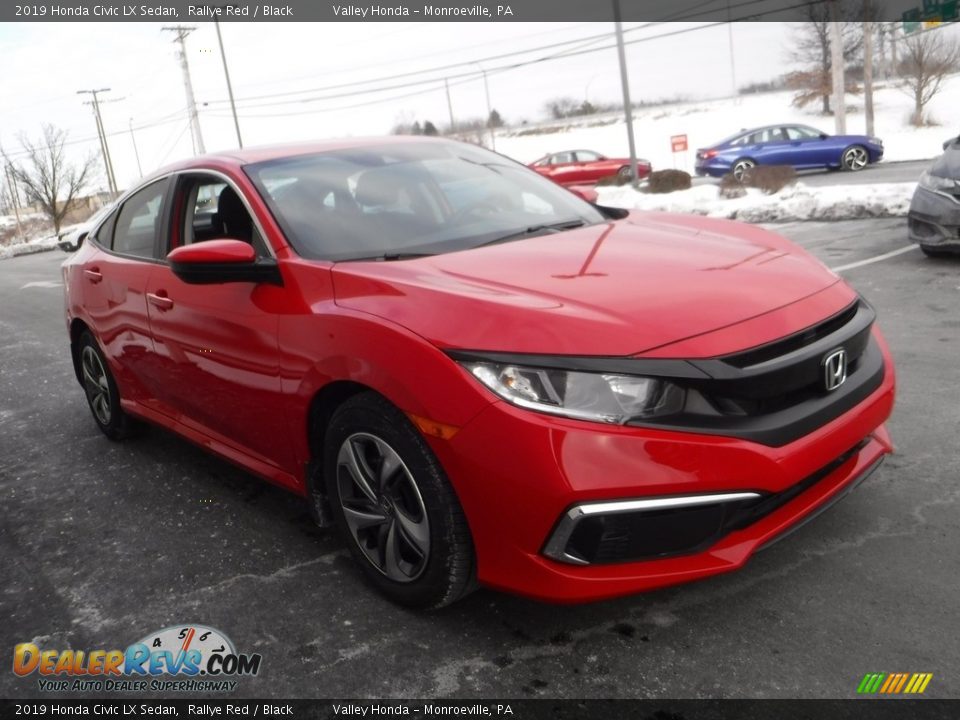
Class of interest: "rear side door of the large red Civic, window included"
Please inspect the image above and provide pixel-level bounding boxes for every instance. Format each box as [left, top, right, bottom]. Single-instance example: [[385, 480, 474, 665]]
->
[[79, 178, 170, 406]]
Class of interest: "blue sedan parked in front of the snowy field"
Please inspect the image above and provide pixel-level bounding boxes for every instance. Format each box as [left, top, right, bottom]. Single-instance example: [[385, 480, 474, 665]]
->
[[696, 125, 883, 178]]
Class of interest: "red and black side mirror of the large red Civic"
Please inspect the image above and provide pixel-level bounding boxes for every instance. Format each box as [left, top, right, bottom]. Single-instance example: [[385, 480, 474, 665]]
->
[[167, 239, 283, 285]]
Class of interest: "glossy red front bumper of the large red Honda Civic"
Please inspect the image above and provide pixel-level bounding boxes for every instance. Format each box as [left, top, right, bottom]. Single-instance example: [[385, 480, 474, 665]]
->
[[430, 333, 894, 602]]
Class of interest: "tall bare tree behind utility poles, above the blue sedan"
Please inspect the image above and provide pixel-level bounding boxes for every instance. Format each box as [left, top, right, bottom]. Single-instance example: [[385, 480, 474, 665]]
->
[[786, 0, 863, 115]]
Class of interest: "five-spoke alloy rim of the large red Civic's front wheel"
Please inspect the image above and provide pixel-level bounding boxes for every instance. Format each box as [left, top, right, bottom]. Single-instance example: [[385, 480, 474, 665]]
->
[[337, 433, 430, 583]]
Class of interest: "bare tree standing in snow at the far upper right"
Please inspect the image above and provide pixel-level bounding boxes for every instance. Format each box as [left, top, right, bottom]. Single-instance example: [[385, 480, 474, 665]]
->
[[900, 31, 960, 127]]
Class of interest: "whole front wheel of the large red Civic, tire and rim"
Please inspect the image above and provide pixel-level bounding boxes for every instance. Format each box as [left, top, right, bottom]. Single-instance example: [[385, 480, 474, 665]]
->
[[324, 392, 476, 609]]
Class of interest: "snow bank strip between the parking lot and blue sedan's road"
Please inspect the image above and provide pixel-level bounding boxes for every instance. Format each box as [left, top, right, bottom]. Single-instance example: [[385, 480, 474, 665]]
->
[[597, 183, 917, 223]]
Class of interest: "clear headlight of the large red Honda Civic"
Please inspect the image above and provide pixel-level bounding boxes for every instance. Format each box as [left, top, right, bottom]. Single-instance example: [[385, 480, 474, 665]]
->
[[461, 361, 686, 425]]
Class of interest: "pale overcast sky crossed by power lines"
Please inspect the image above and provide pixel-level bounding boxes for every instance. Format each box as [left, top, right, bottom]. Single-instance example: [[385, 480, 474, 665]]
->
[[0, 22, 796, 189]]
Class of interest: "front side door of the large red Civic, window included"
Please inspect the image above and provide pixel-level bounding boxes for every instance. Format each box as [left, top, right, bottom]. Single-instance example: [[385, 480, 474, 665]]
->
[[146, 172, 293, 477]]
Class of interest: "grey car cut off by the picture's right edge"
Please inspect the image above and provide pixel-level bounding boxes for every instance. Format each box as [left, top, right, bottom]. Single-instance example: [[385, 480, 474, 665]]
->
[[907, 137, 960, 257]]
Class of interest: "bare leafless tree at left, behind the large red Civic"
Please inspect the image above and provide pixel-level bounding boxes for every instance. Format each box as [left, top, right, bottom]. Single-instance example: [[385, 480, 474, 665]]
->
[[4, 125, 96, 234]]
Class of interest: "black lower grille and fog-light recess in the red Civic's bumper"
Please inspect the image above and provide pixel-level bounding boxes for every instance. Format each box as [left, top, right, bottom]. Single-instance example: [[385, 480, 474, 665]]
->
[[544, 439, 868, 565]]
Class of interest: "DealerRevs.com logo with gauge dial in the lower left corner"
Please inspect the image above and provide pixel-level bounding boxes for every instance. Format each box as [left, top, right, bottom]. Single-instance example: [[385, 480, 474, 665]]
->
[[13, 625, 262, 692]]
